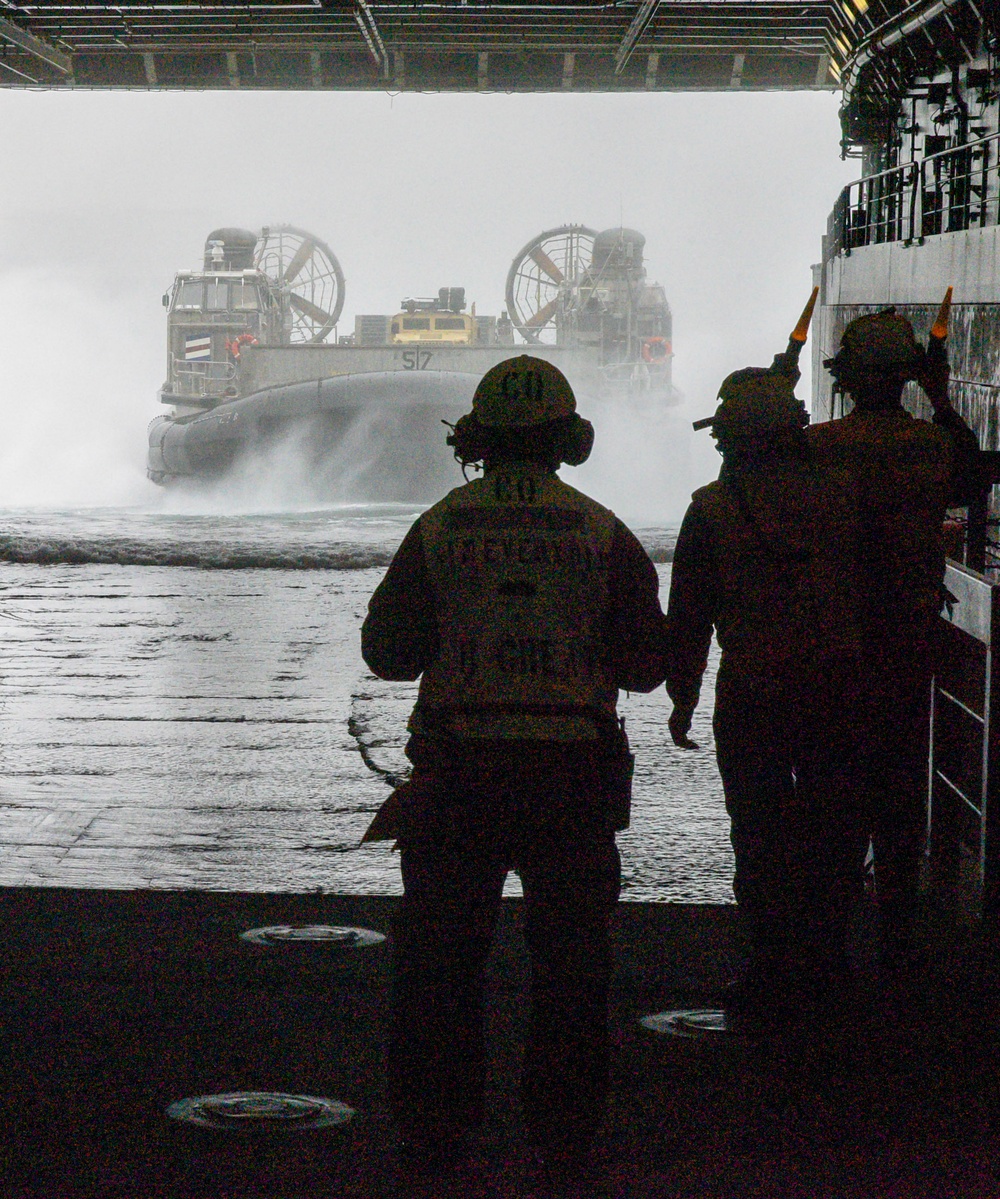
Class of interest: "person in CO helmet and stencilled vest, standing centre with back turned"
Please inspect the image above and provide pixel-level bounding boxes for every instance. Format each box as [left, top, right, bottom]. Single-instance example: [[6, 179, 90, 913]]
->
[[362, 355, 663, 1189]]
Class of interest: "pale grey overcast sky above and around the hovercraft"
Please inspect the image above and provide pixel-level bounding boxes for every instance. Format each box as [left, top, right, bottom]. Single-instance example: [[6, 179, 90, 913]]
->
[[0, 90, 856, 504]]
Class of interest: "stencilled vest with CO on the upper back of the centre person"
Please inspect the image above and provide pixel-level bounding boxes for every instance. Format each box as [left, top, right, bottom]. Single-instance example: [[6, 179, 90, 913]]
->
[[410, 463, 618, 741]]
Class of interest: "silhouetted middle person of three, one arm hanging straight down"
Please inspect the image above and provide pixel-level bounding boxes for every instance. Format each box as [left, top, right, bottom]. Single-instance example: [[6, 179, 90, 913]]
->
[[667, 369, 867, 1014]]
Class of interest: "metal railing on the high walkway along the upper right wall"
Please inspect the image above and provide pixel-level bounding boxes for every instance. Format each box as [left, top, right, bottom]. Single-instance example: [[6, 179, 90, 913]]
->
[[826, 133, 1000, 257]]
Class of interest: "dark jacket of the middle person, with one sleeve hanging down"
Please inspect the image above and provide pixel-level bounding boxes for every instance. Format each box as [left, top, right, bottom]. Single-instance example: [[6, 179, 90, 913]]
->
[[667, 462, 860, 703]]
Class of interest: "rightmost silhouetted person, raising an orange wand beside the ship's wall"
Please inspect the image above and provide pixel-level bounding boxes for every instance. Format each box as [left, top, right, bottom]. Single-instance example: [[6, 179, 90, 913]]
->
[[808, 297, 978, 965]]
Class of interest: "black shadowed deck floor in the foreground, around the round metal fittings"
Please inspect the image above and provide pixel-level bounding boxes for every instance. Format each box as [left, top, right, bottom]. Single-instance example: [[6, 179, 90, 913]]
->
[[0, 888, 1000, 1199]]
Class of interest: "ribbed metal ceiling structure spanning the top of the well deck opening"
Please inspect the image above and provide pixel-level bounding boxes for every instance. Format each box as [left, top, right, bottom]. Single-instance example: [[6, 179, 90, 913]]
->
[[0, 0, 882, 91]]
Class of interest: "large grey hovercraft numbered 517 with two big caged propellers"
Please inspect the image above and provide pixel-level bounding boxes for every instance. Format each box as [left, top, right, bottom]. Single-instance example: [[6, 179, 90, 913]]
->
[[147, 225, 680, 502]]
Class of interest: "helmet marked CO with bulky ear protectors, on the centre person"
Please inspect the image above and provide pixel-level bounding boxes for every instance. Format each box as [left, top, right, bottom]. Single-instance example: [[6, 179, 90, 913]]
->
[[447, 354, 594, 466]]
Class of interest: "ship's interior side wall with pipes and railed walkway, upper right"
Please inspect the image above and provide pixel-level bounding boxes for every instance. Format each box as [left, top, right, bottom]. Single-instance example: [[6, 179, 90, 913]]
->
[[813, 0, 1000, 462]]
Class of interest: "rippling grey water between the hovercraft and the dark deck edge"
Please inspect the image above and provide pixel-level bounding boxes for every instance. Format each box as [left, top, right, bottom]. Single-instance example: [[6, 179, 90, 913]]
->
[[0, 505, 733, 903]]
